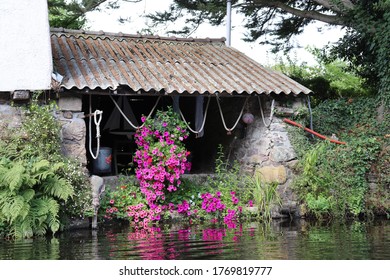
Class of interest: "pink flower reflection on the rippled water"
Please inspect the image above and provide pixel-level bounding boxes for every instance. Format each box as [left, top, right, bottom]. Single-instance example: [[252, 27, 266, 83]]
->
[[106, 225, 253, 260]]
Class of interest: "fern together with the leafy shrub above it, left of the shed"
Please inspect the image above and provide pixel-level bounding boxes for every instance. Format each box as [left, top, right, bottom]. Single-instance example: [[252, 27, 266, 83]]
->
[[0, 93, 92, 238]]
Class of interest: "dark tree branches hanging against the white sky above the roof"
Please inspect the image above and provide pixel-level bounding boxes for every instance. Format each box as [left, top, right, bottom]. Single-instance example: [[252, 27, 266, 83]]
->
[[148, 0, 355, 48]]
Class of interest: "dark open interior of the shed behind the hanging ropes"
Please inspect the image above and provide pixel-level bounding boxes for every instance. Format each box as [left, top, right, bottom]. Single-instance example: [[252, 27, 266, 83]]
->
[[83, 94, 243, 176]]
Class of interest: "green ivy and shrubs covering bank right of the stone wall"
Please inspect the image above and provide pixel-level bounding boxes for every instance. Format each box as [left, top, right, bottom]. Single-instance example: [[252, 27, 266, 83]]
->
[[292, 97, 390, 217]]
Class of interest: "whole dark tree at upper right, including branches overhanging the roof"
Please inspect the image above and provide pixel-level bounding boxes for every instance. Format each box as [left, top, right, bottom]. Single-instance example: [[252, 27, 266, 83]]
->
[[148, 0, 390, 104]]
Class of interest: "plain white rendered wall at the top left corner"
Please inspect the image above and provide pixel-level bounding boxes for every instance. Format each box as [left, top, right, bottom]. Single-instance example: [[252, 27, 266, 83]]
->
[[0, 0, 53, 91]]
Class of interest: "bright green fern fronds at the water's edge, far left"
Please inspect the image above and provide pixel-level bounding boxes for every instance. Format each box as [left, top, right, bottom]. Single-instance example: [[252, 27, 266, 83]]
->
[[0, 157, 73, 238]]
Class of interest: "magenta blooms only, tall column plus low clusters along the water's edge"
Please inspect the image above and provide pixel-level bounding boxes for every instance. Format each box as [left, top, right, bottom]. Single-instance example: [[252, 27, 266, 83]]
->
[[106, 109, 251, 229]]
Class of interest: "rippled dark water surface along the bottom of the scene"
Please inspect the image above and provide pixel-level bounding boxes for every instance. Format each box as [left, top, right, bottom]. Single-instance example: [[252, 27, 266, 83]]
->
[[0, 220, 390, 260]]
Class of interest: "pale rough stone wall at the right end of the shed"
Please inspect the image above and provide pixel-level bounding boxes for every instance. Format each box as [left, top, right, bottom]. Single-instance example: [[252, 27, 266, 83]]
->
[[234, 99, 304, 216]]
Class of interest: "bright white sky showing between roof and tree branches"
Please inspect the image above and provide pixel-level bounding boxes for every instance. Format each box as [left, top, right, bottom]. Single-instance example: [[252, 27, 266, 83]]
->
[[87, 0, 343, 65]]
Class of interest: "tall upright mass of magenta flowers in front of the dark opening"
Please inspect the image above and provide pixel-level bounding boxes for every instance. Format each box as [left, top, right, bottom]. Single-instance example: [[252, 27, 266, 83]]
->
[[134, 108, 191, 210]]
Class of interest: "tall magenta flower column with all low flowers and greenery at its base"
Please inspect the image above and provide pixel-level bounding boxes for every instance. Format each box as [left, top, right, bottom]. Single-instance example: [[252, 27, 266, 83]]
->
[[100, 108, 258, 229]]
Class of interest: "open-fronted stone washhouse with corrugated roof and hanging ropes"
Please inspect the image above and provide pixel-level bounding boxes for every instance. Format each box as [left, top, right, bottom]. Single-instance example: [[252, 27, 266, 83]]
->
[[0, 28, 312, 221]]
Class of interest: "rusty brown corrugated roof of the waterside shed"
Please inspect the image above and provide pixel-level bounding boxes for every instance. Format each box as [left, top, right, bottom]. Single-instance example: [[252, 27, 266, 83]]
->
[[51, 29, 311, 94]]
